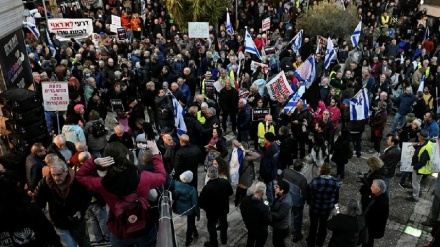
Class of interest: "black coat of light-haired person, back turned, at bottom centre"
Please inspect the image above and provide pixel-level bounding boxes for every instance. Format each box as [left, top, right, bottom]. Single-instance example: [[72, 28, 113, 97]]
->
[[240, 195, 272, 235]]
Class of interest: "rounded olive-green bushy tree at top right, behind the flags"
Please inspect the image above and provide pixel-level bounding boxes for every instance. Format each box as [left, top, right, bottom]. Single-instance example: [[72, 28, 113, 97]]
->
[[296, 1, 359, 38]]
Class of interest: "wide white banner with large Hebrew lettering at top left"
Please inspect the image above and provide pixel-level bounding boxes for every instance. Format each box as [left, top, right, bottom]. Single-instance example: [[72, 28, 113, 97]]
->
[[47, 18, 93, 41]]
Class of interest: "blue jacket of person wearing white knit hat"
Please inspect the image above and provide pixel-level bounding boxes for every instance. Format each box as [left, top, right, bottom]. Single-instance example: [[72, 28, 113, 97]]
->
[[173, 181, 200, 216]]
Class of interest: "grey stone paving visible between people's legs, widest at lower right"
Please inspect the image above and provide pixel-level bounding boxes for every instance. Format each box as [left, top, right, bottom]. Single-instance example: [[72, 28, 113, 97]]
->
[[99, 114, 435, 247]]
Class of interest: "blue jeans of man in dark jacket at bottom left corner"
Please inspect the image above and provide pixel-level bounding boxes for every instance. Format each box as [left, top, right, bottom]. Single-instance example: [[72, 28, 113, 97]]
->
[[55, 219, 91, 247]]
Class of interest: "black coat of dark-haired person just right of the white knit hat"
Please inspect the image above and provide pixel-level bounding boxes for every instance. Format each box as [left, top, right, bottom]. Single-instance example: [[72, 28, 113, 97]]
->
[[199, 178, 234, 217]]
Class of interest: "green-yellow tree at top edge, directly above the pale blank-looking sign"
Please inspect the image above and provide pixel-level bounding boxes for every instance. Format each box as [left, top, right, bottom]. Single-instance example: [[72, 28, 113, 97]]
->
[[166, 0, 231, 31]]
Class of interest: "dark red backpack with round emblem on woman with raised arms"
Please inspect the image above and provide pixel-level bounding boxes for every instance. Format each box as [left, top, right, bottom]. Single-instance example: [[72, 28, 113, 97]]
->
[[111, 174, 149, 239]]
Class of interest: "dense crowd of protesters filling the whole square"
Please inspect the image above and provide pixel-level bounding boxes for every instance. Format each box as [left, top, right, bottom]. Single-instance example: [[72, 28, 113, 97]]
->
[[0, 0, 440, 247]]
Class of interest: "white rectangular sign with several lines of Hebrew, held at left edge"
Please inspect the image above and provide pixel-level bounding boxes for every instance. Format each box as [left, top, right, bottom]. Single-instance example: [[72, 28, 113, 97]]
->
[[41, 82, 69, 111]]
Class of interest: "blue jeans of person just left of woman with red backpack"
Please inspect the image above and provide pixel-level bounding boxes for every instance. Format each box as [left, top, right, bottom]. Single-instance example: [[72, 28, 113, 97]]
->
[[86, 203, 110, 242]]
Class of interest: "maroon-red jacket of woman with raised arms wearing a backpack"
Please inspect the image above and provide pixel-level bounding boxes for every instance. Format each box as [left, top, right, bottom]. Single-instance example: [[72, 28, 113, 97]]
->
[[76, 154, 166, 235]]
